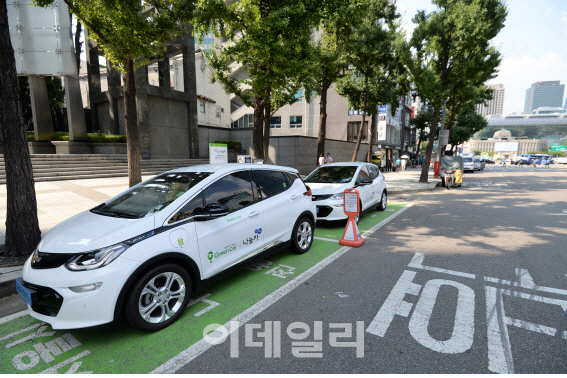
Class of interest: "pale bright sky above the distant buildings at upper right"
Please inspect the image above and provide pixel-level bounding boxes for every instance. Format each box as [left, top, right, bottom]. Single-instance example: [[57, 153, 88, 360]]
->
[[396, 0, 567, 114]]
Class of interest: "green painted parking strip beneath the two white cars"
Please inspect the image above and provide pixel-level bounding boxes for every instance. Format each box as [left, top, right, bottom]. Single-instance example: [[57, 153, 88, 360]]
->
[[0, 204, 406, 374]]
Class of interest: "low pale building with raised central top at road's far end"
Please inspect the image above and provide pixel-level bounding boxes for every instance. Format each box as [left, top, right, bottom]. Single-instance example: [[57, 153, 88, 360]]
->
[[463, 129, 547, 158]]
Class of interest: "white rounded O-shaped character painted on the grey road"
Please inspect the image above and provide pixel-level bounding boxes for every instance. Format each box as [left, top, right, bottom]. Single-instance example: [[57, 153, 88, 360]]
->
[[409, 279, 475, 354]]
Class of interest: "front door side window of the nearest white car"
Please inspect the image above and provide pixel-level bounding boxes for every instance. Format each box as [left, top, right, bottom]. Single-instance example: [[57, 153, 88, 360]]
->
[[205, 171, 254, 212]]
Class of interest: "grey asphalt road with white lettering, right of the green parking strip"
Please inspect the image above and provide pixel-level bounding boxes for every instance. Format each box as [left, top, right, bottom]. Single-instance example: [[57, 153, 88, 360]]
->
[[174, 166, 567, 374]]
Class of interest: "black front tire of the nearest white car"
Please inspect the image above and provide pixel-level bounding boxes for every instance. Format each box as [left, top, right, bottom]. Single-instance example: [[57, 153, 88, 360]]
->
[[124, 264, 192, 332]]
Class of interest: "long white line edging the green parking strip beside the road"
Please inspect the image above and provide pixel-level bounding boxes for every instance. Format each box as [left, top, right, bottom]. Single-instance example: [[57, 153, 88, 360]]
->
[[151, 203, 413, 374]]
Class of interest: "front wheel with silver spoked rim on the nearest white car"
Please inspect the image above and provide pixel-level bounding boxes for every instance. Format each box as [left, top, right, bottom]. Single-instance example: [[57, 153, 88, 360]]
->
[[125, 264, 191, 332]]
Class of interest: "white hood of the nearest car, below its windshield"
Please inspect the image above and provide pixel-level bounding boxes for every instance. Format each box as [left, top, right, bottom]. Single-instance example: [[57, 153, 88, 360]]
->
[[39, 211, 154, 253]]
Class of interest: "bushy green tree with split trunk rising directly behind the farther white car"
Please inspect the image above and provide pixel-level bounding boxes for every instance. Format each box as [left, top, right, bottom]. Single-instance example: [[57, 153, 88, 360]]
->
[[337, 0, 408, 161]]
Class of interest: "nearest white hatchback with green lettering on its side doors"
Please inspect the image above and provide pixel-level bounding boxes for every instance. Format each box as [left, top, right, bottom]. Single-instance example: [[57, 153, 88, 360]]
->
[[16, 164, 316, 331]]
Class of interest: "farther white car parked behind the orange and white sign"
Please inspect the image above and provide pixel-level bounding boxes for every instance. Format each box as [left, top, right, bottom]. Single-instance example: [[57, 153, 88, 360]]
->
[[305, 163, 388, 221]]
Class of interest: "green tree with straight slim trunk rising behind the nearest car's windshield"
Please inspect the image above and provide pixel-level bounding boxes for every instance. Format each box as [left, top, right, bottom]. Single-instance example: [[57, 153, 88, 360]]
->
[[36, 0, 194, 186]]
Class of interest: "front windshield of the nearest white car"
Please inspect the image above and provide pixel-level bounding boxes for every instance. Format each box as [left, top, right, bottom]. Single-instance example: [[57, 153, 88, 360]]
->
[[91, 172, 211, 218]]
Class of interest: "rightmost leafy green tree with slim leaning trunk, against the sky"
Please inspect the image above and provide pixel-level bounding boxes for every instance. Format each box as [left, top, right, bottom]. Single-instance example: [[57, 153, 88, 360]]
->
[[404, 0, 507, 182]]
